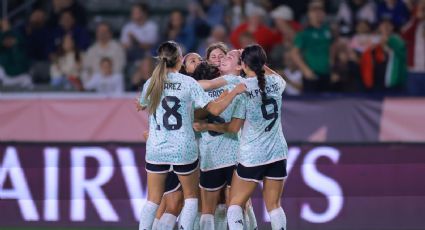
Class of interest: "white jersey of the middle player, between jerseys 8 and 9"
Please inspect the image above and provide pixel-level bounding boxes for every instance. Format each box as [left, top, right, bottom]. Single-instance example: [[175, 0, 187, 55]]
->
[[199, 82, 244, 171]]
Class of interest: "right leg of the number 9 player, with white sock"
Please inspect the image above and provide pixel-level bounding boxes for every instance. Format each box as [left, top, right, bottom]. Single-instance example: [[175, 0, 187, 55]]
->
[[263, 160, 286, 230]]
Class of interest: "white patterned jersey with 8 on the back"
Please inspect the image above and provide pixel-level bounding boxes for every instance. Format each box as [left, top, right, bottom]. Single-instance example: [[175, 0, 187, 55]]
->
[[140, 73, 212, 165]]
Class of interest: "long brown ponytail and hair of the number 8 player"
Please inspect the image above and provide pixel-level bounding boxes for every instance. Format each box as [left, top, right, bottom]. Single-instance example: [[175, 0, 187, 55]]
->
[[145, 41, 181, 114]]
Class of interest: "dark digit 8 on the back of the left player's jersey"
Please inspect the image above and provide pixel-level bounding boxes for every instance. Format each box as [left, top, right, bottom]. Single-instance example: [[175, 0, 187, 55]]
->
[[162, 96, 182, 130]]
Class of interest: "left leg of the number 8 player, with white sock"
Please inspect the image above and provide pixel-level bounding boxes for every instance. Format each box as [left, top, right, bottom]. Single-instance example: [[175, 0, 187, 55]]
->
[[139, 163, 169, 230]]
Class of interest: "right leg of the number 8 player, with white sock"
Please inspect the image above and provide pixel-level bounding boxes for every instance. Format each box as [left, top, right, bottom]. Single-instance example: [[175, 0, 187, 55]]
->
[[174, 161, 199, 230]]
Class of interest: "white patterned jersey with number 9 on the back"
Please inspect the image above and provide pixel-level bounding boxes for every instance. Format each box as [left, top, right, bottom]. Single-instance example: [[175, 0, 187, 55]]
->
[[232, 75, 288, 167]]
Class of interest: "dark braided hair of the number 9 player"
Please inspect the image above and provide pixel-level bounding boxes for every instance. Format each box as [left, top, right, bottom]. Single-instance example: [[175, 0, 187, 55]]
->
[[241, 44, 267, 100]]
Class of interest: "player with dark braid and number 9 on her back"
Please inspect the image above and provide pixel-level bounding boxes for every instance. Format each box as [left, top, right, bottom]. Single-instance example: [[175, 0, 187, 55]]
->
[[202, 45, 288, 230]]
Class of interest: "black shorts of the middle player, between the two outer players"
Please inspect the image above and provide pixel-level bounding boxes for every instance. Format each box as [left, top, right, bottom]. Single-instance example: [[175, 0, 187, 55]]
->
[[199, 165, 235, 192]]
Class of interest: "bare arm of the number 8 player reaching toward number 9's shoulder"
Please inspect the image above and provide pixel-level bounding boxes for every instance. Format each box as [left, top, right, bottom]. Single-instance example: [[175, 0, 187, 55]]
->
[[205, 83, 246, 116]]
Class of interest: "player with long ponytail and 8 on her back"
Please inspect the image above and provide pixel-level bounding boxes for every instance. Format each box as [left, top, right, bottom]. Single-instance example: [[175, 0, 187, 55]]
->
[[139, 41, 245, 229]]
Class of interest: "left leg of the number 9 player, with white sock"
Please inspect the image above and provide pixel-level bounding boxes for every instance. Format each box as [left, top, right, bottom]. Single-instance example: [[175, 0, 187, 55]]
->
[[227, 164, 262, 230]]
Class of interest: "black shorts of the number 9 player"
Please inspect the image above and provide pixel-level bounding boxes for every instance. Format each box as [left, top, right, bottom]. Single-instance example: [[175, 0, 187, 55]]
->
[[236, 159, 287, 183]]
